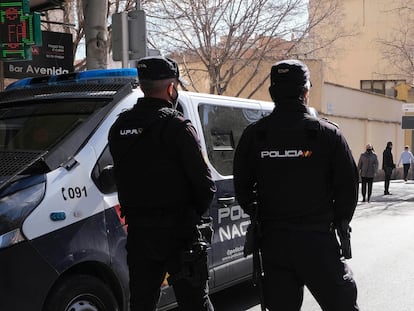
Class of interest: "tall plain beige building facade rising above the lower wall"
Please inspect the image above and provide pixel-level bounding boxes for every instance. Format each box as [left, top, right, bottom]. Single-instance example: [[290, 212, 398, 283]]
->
[[310, 0, 403, 89]]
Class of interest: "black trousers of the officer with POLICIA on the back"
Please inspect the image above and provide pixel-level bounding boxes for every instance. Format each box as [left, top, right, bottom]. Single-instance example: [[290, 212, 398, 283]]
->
[[261, 228, 359, 311]]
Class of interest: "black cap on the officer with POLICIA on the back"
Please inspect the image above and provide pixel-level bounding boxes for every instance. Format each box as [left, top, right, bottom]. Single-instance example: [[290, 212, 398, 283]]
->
[[270, 59, 310, 87]]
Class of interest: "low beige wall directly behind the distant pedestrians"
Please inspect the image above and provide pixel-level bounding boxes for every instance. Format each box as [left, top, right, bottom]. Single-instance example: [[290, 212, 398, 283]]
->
[[320, 82, 404, 165]]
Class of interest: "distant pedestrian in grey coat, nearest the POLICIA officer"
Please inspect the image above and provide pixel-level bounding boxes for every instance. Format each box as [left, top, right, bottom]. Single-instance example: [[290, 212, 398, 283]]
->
[[358, 144, 378, 202]]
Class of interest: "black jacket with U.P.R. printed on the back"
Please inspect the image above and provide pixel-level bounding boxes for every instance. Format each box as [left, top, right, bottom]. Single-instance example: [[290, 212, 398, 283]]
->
[[108, 98, 215, 226]]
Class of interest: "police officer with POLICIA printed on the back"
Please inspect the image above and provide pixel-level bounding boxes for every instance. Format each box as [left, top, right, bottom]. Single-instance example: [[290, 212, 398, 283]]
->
[[234, 60, 359, 311]]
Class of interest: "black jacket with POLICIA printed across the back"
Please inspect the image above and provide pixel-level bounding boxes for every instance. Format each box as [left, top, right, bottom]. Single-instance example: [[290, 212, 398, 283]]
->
[[234, 102, 358, 227]]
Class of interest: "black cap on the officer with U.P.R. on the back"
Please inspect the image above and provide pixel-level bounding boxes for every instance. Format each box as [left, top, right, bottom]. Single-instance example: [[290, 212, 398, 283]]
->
[[137, 56, 180, 80]]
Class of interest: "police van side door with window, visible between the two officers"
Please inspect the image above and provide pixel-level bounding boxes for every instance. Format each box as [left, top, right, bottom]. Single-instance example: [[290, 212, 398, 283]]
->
[[193, 97, 262, 287]]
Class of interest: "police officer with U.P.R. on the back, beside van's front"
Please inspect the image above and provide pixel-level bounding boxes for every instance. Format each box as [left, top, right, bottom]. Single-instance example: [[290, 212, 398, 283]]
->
[[109, 56, 215, 311]]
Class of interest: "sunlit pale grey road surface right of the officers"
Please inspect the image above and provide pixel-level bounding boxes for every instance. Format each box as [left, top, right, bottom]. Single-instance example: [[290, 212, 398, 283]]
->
[[244, 179, 414, 311]]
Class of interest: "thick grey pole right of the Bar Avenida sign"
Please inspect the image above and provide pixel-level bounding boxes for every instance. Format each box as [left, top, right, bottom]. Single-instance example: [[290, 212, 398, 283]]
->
[[83, 0, 108, 69]]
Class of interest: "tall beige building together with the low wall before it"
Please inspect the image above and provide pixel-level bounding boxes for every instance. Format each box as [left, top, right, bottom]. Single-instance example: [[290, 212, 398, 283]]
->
[[302, 0, 414, 173]]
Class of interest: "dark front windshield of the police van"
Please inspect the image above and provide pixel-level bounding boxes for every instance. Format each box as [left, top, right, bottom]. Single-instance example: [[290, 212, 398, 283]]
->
[[0, 100, 107, 151]]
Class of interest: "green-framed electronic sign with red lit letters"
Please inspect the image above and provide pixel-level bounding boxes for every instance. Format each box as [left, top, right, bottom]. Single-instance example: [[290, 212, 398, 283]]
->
[[0, 0, 42, 61]]
